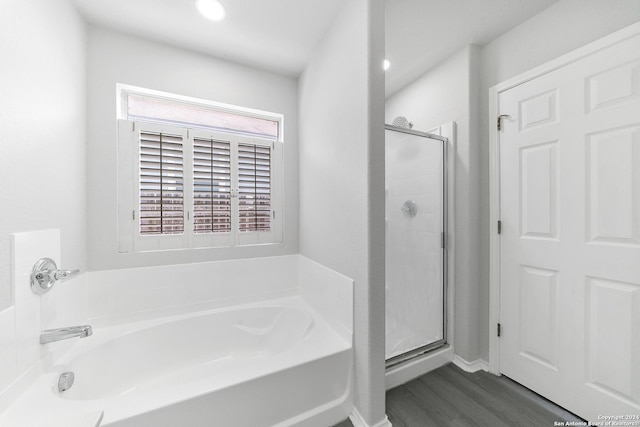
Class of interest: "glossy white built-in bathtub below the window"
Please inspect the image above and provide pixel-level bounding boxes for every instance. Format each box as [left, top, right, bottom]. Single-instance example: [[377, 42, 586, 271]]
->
[[0, 296, 353, 427]]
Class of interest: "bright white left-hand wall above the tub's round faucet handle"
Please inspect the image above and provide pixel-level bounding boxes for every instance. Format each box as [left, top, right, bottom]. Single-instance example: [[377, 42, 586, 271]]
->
[[0, 0, 87, 309]]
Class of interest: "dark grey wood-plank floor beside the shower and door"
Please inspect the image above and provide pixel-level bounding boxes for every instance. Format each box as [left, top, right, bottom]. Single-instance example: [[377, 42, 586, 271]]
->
[[335, 364, 583, 427]]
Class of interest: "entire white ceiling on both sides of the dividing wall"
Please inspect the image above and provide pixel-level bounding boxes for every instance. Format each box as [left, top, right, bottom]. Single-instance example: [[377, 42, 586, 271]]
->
[[72, 0, 557, 94]]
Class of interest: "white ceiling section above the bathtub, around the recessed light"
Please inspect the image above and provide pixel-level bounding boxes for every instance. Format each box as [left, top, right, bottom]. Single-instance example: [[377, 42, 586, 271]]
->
[[72, 0, 346, 76]]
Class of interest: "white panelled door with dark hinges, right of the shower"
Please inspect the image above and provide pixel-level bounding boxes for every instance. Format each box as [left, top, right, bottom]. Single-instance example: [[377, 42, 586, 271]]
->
[[499, 30, 640, 425]]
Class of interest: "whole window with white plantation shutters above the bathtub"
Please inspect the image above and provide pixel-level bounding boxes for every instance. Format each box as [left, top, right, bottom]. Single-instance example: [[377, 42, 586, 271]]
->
[[118, 88, 282, 252]]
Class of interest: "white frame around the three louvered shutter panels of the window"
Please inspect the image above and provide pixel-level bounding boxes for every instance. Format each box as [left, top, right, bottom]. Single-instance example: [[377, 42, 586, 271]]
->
[[118, 85, 284, 253]]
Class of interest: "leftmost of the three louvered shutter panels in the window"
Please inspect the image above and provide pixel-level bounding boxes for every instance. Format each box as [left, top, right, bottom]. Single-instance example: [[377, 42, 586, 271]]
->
[[139, 131, 184, 235]]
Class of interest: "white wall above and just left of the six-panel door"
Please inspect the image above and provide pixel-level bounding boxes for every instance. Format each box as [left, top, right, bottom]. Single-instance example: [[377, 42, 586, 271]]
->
[[479, 0, 640, 360]]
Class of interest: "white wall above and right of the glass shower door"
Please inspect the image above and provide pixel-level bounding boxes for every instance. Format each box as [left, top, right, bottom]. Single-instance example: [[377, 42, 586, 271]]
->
[[385, 46, 482, 361]]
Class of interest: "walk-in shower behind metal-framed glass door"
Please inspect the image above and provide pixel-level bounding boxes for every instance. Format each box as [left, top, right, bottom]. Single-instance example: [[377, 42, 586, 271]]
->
[[385, 123, 447, 367]]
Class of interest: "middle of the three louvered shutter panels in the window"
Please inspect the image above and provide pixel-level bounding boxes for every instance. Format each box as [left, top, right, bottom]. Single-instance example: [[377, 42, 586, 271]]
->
[[193, 138, 231, 233]]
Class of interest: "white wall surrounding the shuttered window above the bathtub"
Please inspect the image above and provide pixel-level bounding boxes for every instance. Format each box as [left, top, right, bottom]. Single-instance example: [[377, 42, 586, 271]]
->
[[87, 27, 298, 270]]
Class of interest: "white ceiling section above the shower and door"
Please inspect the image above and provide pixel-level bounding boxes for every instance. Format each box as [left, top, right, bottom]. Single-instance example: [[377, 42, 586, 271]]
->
[[385, 0, 558, 96]]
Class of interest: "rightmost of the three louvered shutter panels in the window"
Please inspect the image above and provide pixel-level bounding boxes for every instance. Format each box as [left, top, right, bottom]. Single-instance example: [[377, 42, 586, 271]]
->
[[238, 143, 271, 232]]
